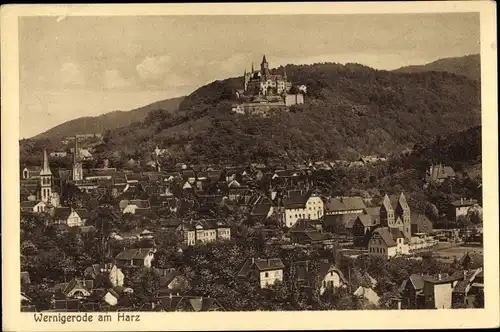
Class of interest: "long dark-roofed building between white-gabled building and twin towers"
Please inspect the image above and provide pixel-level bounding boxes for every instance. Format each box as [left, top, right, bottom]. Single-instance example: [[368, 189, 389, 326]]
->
[[324, 196, 366, 232]]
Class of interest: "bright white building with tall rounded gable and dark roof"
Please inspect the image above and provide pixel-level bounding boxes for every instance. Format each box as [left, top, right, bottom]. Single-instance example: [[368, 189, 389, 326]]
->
[[283, 192, 323, 228]]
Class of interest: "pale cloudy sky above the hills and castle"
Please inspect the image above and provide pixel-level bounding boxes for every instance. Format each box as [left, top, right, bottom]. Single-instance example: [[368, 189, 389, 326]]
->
[[19, 13, 480, 138]]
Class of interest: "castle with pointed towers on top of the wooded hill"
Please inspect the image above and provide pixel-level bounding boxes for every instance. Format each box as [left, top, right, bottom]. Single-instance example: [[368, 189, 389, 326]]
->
[[232, 55, 305, 115]]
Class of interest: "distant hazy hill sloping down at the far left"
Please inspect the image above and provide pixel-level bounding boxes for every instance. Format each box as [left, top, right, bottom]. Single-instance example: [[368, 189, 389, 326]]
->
[[33, 97, 184, 139]]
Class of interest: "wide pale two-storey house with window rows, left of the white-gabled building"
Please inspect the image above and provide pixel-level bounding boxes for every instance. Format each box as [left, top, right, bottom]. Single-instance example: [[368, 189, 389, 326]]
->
[[177, 219, 231, 246]]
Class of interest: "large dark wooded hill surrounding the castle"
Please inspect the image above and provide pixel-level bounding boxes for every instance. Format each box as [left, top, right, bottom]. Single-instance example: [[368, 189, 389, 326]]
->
[[102, 63, 481, 162]]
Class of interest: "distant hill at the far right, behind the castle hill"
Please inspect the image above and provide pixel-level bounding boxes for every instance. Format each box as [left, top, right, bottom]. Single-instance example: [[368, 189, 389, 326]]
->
[[395, 54, 481, 81]]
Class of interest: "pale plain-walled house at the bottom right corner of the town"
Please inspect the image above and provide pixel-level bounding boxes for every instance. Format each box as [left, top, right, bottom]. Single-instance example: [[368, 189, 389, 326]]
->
[[424, 272, 463, 309]]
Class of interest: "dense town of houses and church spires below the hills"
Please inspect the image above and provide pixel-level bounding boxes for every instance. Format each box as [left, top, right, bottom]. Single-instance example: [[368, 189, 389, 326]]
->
[[20, 131, 484, 312]]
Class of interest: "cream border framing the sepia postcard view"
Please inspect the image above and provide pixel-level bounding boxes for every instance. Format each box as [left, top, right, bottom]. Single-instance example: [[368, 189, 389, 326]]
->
[[1, 1, 500, 331]]
